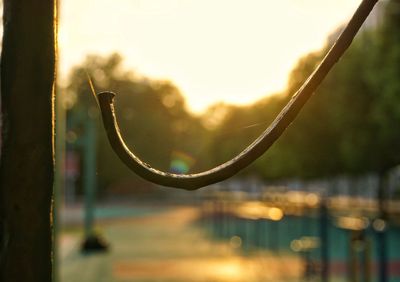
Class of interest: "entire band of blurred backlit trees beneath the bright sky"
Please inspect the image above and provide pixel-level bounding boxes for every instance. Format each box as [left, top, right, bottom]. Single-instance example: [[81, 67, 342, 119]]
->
[[67, 0, 400, 188]]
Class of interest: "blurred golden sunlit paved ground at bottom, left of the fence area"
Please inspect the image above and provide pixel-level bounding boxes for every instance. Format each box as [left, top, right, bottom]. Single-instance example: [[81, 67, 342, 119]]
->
[[60, 205, 301, 282]]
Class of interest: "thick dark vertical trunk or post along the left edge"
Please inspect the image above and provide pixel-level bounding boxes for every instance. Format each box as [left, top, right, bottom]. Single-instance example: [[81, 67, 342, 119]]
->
[[0, 0, 56, 282]]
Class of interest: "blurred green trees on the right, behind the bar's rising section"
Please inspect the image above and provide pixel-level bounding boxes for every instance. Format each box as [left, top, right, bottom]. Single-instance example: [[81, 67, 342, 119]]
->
[[205, 0, 400, 178]]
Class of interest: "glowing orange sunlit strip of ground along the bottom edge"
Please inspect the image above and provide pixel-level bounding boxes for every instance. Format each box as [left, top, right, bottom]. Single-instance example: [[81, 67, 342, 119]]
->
[[113, 257, 301, 282]]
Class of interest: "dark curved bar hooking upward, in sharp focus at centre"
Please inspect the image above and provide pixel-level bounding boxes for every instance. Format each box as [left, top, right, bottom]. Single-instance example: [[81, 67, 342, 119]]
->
[[98, 0, 378, 190]]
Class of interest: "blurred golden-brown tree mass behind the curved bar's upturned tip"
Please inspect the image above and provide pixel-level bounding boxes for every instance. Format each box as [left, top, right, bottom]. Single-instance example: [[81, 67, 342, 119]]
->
[[65, 54, 204, 193]]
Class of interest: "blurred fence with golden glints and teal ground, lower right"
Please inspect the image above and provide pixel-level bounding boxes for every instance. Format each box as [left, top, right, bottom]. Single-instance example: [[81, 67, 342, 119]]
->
[[201, 173, 400, 281]]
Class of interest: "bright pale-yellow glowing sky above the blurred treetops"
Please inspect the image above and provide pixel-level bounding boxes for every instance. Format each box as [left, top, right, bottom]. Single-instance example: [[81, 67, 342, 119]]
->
[[59, 0, 361, 113]]
